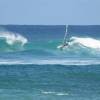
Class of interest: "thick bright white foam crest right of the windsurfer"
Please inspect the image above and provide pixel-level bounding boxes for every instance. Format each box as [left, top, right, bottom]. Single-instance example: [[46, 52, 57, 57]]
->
[[71, 37, 100, 49]]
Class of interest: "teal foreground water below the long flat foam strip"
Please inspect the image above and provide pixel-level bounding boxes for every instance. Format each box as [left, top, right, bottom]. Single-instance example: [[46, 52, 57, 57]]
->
[[0, 65, 100, 100]]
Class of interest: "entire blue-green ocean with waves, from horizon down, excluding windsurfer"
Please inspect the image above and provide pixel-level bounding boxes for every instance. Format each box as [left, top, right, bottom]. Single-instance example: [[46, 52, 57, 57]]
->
[[0, 25, 100, 100]]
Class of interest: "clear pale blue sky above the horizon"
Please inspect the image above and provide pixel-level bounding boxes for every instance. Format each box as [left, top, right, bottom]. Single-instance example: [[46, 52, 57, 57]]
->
[[0, 0, 100, 25]]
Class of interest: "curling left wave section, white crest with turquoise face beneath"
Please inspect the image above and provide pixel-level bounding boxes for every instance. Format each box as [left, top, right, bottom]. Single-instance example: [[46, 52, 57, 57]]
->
[[0, 32, 28, 52]]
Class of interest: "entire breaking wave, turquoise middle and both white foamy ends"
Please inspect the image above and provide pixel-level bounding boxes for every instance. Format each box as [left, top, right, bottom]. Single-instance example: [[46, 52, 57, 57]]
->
[[0, 32, 100, 58]]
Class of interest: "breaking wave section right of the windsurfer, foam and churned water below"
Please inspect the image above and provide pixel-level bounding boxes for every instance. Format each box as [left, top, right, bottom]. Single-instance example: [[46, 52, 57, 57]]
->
[[56, 37, 100, 57]]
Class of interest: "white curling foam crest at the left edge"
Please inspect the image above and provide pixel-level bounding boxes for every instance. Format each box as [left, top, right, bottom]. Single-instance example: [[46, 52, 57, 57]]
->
[[0, 32, 28, 45]]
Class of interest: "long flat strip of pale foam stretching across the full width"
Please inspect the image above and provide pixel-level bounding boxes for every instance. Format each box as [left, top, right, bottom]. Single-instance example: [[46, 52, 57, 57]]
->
[[0, 59, 100, 65]]
